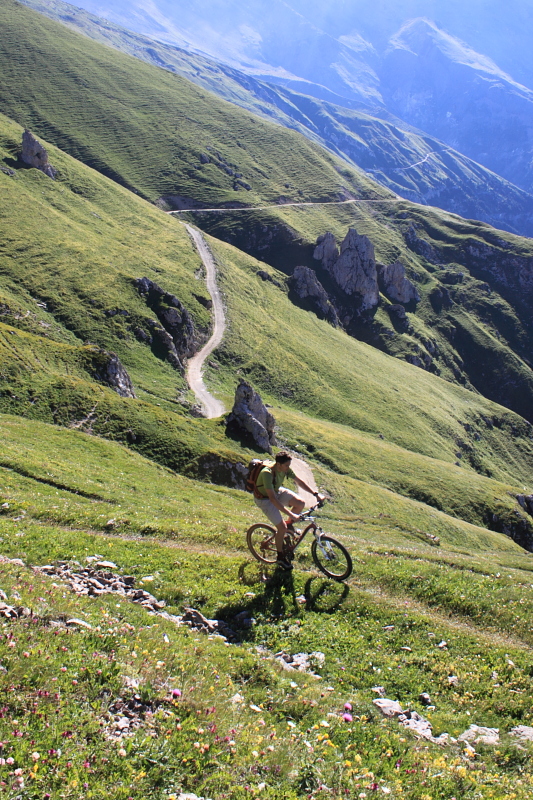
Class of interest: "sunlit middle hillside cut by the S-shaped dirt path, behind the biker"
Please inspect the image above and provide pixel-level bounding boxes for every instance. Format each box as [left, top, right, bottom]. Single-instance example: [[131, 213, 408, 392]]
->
[[0, 112, 533, 547]]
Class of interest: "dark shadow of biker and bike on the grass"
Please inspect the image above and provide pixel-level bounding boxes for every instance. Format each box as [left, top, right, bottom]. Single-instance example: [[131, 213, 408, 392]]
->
[[217, 561, 350, 640]]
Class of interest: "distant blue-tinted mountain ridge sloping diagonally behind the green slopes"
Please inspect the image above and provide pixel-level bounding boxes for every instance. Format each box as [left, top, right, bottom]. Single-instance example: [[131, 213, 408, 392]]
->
[[19, 0, 533, 236]]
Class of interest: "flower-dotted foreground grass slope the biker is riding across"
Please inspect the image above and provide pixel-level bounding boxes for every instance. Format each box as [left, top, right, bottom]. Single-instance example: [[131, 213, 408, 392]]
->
[[0, 415, 533, 800]]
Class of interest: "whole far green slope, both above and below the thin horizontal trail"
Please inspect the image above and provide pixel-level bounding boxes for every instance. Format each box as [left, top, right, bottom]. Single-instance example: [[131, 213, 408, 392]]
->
[[2, 0, 533, 428]]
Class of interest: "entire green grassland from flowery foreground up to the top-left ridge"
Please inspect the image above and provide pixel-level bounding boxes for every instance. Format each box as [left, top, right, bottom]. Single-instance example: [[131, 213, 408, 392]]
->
[[0, 0, 533, 800]]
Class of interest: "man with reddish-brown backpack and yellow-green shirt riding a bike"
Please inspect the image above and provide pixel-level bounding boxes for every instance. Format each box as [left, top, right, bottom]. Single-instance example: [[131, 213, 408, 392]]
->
[[254, 451, 320, 570]]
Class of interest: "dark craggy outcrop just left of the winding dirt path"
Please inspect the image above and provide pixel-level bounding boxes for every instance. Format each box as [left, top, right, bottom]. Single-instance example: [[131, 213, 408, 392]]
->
[[135, 278, 201, 372]]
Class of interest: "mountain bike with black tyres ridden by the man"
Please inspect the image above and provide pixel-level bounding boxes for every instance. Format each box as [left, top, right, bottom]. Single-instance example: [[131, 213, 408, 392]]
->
[[246, 500, 352, 581]]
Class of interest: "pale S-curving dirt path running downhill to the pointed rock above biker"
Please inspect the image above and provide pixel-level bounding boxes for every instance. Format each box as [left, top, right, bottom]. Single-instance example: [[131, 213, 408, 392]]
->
[[185, 225, 226, 419]]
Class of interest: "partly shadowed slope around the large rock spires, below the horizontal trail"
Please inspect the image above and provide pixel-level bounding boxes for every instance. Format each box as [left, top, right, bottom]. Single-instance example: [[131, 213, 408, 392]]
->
[[197, 197, 533, 419]]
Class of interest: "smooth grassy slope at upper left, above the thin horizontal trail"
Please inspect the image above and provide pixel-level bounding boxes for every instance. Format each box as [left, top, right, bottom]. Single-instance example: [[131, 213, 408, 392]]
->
[[0, 0, 382, 209]]
